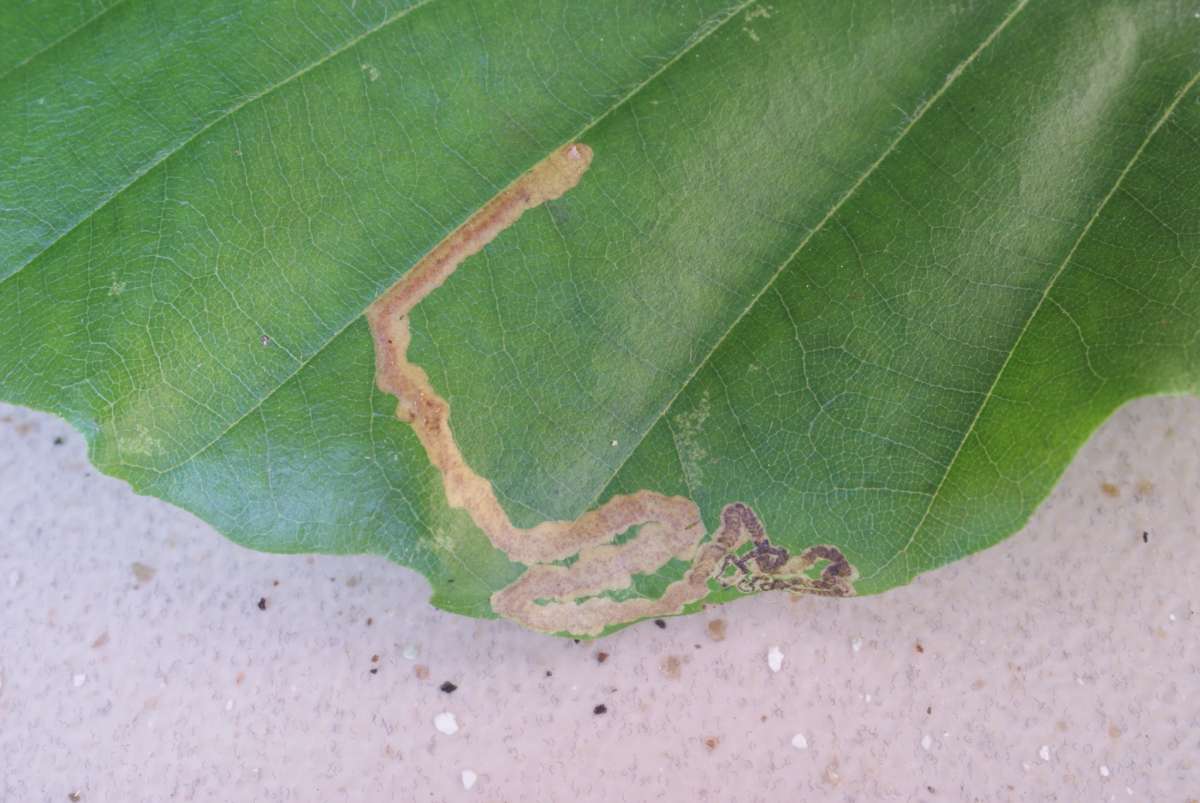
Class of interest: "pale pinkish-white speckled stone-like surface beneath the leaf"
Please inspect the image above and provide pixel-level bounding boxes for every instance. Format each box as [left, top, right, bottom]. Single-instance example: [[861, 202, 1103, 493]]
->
[[0, 400, 1200, 803]]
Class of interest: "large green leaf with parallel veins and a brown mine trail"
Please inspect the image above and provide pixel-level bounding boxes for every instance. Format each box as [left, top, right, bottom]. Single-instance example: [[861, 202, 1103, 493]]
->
[[0, 0, 1200, 634]]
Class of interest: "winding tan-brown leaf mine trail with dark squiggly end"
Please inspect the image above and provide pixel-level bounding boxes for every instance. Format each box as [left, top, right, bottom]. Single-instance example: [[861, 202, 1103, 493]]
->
[[367, 143, 857, 635]]
